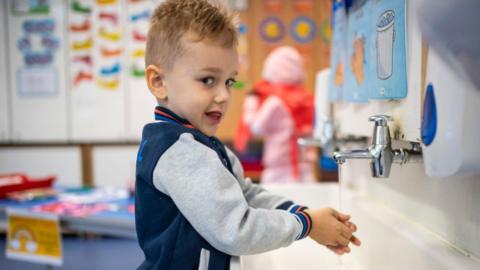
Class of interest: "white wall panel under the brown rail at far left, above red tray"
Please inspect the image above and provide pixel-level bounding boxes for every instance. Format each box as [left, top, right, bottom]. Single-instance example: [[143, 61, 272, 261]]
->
[[0, 146, 82, 186]]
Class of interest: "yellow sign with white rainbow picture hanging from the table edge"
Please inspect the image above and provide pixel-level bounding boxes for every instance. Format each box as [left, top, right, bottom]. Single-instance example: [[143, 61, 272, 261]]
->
[[6, 209, 62, 266]]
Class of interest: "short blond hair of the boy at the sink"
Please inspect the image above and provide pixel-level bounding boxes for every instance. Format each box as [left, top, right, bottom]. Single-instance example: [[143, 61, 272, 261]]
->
[[145, 0, 237, 68]]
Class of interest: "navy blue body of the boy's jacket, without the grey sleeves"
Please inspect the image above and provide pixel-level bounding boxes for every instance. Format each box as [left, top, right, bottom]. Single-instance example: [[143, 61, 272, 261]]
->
[[135, 113, 233, 270]]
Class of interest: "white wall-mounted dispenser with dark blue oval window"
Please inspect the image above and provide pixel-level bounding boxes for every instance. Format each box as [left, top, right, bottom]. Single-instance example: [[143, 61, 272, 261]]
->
[[421, 49, 480, 177]]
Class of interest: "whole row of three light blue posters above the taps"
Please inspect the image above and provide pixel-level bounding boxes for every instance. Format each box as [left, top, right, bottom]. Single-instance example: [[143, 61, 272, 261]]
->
[[329, 0, 407, 103]]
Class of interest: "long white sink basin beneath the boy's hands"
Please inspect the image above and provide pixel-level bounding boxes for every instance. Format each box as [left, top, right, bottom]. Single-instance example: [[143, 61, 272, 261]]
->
[[241, 184, 480, 270]]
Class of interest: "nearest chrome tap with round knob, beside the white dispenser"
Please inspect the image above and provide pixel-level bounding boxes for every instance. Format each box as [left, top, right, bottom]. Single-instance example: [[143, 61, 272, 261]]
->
[[333, 115, 421, 178]]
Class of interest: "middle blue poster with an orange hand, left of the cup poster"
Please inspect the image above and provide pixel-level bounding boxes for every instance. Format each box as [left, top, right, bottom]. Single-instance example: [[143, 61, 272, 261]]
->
[[343, 0, 374, 103]]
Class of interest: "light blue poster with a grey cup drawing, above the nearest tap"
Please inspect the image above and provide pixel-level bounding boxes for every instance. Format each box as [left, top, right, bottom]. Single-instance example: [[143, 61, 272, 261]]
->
[[368, 0, 407, 99]]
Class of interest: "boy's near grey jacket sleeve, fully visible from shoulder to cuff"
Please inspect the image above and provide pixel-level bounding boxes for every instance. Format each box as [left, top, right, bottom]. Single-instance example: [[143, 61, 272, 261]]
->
[[153, 133, 303, 256]]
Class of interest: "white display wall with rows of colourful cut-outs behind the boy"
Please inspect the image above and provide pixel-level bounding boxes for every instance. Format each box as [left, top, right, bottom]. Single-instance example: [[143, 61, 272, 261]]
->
[[6, 0, 161, 142]]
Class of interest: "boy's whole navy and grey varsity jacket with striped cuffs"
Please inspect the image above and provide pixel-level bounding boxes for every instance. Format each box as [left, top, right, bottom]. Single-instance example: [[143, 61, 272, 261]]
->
[[135, 107, 311, 270]]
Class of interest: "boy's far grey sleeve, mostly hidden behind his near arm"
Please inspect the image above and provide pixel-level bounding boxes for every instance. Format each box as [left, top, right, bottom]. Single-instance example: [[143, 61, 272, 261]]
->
[[226, 147, 290, 209]]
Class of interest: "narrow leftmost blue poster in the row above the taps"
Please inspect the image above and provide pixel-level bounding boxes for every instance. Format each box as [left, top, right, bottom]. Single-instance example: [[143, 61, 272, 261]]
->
[[328, 0, 347, 102]]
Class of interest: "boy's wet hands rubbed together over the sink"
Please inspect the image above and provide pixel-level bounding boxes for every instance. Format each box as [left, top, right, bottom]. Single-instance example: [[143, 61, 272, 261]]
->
[[305, 208, 361, 255]]
